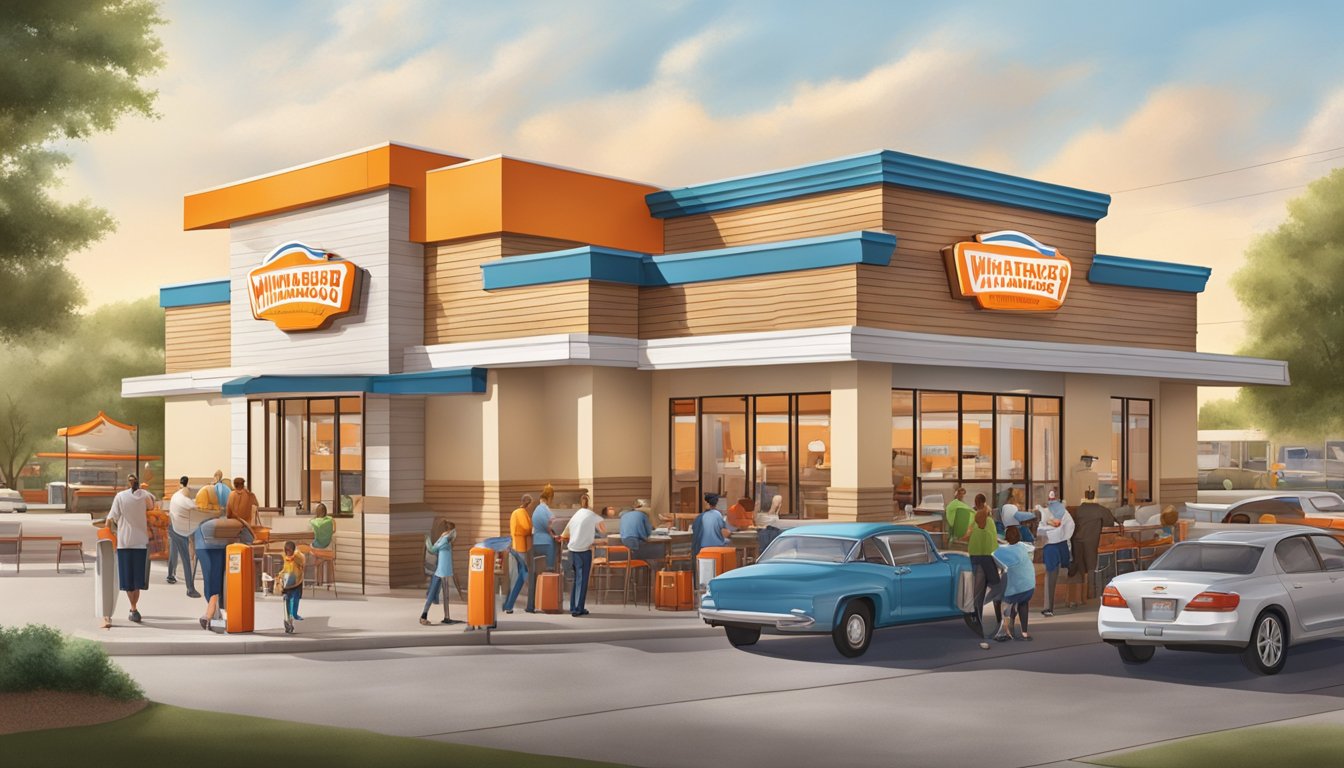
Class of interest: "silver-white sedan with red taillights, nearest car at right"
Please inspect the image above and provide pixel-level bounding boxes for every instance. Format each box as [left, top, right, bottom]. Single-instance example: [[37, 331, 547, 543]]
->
[[1097, 525, 1344, 675]]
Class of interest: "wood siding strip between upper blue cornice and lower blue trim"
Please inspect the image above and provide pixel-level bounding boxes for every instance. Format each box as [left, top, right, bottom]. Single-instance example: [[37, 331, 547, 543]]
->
[[663, 184, 883, 253]]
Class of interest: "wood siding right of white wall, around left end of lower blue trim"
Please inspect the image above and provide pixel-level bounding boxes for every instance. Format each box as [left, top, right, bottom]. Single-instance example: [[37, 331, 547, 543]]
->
[[425, 234, 638, 344]]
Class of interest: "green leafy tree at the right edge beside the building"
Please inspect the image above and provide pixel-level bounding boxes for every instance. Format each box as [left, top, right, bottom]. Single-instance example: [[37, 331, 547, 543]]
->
[[1232, 168, 1344, 437]]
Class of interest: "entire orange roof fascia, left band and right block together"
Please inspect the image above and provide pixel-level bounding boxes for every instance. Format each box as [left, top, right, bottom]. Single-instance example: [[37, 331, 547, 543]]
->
[[183, 144, 663, 253]]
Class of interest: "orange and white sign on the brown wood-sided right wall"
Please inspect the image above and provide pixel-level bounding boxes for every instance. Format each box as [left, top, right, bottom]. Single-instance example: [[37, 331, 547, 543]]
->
[[942, 230, 1073, 312]]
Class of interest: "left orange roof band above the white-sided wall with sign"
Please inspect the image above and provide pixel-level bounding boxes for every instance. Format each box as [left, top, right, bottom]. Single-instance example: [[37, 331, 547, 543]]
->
[[183, 144, 464, 239]]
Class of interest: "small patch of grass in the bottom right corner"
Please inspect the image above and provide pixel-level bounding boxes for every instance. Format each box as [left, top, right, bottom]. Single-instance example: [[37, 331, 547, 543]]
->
[[1085, 725, 1344, 768]]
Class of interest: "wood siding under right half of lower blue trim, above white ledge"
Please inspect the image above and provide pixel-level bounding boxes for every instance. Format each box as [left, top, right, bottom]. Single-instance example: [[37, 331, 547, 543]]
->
[[640, 266, 857, 339]]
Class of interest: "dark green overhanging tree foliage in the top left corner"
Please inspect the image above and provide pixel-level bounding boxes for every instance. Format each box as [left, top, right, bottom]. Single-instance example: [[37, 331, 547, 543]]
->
[[0, 0, 164, 339]]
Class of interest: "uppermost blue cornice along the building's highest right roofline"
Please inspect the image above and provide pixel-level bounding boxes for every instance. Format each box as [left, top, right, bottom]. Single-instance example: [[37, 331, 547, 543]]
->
[[645, 149, 1110, 222]]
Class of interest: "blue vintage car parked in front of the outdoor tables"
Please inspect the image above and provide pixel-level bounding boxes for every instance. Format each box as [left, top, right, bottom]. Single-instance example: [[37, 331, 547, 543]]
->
[[700, 523, 980, 658]]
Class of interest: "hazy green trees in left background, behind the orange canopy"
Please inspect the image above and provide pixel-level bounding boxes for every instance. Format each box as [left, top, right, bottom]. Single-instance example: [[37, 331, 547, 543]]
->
[[0, 297, 164, 487]]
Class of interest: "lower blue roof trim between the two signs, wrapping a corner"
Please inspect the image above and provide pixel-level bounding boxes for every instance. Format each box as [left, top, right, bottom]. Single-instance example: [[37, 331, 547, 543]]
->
[[481, 231, 896, 291]]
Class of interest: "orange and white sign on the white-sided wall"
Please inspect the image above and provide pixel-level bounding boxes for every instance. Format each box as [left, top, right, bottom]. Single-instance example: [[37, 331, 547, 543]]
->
[[247, 242, 359, 331]]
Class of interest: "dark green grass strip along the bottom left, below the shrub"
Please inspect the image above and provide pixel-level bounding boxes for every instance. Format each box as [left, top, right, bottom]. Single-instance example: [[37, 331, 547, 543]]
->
[[0, 703, 626, 768]]
